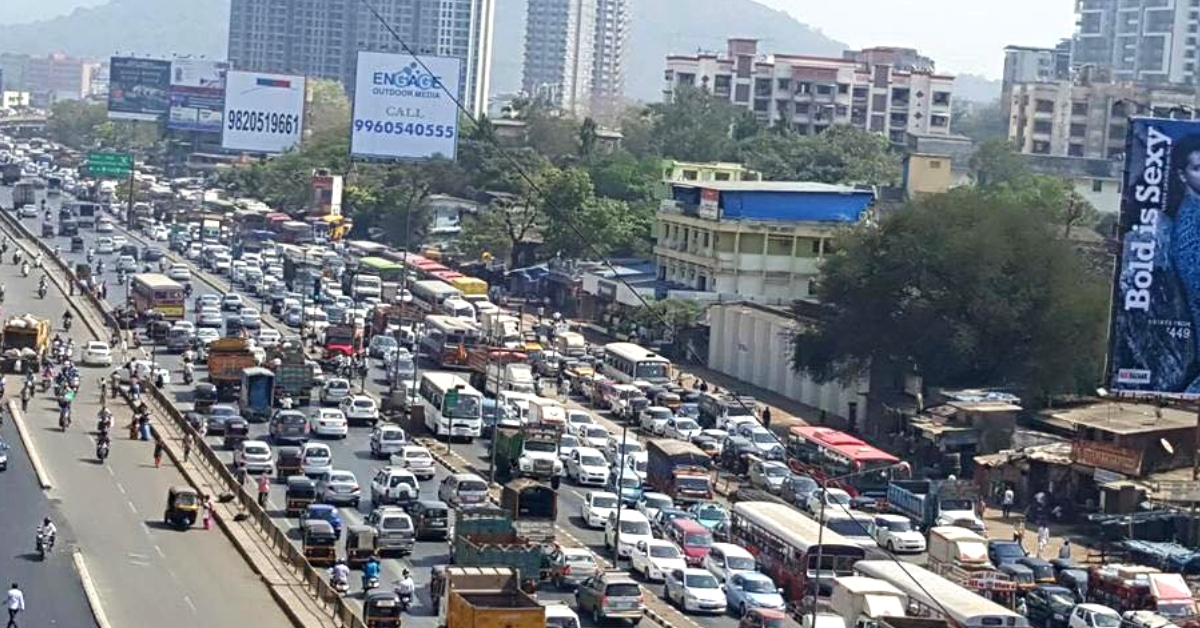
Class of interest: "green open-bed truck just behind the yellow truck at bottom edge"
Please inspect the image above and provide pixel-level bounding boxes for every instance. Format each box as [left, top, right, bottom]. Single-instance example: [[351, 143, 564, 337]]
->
[[450, 507, 542, 591]]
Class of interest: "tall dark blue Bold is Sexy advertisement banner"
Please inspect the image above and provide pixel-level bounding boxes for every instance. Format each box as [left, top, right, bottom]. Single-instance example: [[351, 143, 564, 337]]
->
[[1108, 118, 1200, 397]]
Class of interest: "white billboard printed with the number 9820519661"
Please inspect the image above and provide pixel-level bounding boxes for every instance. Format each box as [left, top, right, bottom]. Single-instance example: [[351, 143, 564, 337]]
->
[[221, 70, 305, 152]]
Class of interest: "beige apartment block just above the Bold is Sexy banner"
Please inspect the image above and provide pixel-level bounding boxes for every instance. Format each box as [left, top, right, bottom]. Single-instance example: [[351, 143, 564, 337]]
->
[[1008, 72, 1200, 160]]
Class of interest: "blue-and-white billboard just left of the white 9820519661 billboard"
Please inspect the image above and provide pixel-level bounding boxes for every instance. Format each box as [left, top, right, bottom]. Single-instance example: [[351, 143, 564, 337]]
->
[[167, 59, 229, 133]]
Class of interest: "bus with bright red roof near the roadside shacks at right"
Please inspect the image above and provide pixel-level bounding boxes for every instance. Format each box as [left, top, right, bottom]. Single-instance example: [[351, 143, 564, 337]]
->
[[787, 425, 912, 497]]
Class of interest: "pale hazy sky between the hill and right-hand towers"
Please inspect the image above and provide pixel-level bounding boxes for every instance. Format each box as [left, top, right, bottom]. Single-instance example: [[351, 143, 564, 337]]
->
[[758, 0, 1075, 78]]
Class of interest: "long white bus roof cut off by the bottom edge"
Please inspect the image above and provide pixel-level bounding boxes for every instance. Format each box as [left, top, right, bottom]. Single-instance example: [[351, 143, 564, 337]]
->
[[854, 561, 1030, 628]]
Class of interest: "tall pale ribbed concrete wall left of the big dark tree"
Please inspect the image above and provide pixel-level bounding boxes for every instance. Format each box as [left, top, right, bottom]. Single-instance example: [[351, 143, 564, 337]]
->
[[708, 304, 868, 426]]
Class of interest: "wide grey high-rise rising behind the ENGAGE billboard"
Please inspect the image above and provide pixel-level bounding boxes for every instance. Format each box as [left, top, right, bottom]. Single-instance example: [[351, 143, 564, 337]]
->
[[229, 0, 496, 114]]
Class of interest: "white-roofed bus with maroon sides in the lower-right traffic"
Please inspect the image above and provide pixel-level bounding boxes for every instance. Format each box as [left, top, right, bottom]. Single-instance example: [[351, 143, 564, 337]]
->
[[730, 502, 866, 602]]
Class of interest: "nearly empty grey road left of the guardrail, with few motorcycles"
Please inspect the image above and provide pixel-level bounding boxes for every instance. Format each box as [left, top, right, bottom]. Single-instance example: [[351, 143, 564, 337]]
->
[[0, 189, 297, 628]]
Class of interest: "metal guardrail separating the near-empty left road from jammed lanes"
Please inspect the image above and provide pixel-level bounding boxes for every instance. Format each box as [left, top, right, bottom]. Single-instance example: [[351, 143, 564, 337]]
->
[[0, 210, 366, 628]]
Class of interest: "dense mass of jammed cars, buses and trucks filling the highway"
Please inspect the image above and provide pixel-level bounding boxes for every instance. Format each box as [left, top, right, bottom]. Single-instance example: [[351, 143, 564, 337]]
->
[[0, 136, 1196, 628]]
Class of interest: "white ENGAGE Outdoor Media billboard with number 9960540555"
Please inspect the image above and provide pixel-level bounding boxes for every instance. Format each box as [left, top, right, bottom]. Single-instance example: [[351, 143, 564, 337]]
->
[[350, 52, 462, 160]]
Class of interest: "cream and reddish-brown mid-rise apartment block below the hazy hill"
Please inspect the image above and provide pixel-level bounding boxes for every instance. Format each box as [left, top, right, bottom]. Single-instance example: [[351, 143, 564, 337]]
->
[[664, 38, 954, 143]]
